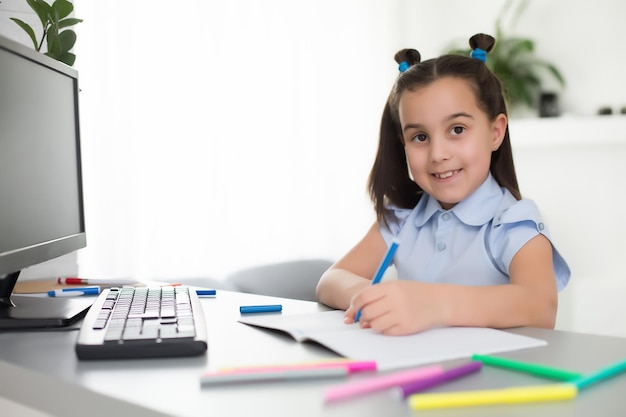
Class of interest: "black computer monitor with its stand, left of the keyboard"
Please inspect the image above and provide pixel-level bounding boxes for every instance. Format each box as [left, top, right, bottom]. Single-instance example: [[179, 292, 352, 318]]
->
[[0, 37, 93, 329]]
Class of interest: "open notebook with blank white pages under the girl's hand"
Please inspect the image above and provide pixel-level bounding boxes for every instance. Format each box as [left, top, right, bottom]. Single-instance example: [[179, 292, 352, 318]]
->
[[239, 310, 547, 370]]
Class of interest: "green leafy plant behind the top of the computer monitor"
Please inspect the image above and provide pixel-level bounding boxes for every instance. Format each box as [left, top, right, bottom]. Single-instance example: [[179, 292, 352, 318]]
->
[[11, 0, 82, 66]]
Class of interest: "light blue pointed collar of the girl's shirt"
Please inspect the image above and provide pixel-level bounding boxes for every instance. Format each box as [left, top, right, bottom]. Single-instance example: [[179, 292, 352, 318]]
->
[[415, 173, 504, 227]]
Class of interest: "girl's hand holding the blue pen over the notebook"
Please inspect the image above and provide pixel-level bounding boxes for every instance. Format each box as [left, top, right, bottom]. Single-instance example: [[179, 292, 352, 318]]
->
[[344, 280, 445, 336]]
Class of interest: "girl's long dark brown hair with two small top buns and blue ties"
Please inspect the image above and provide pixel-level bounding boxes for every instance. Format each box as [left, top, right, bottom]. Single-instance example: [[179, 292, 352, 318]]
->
[[368, 34, 522, 225]]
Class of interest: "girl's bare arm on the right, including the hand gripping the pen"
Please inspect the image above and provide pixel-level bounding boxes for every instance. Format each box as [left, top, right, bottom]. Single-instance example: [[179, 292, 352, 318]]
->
[[338, 235, 558, 335]]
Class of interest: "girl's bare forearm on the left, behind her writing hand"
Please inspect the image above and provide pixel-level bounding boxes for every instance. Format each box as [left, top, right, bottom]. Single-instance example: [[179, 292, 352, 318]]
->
[[317, 223, 387, 310]]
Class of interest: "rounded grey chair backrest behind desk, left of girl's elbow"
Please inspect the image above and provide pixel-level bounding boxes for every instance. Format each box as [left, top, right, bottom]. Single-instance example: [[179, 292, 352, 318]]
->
[[226, 259, 333, 301]]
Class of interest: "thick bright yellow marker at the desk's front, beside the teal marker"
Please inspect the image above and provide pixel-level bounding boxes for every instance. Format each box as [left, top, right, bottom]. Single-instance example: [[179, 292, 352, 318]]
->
[[408, 384, 578, 410]]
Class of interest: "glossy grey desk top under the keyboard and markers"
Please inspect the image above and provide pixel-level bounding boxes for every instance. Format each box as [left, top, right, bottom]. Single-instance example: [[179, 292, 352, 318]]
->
[[0, 291, 626, 417]]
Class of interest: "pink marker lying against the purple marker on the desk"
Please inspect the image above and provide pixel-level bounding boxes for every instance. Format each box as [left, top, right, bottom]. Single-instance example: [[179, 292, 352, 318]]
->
[[324, 365, 444, 402]]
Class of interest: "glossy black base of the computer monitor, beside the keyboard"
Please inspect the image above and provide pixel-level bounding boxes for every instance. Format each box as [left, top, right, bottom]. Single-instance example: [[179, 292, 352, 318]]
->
[[0, 272, 96, 330]]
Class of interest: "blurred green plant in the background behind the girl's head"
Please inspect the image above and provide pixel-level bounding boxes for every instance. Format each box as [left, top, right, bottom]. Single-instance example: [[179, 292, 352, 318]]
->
[[448, 0, 565, 114]]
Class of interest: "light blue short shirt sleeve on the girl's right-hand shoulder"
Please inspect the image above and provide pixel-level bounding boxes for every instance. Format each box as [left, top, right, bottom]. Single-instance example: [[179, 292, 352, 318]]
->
[[489, 200, 571, 291]]
